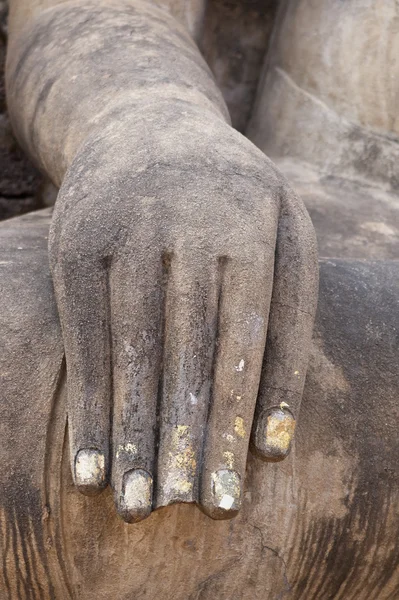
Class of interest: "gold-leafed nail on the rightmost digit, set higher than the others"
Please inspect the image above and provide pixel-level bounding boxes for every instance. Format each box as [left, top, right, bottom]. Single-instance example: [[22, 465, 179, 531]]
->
[[256, 408, 296, 460]]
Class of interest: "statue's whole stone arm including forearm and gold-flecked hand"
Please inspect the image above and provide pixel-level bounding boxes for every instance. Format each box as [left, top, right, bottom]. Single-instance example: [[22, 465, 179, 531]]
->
[[3, 0, 317, 521]]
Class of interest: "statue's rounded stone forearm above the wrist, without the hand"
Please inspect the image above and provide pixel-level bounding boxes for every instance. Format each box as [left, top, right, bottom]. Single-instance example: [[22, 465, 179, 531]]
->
[[7, 0, 228, 185]]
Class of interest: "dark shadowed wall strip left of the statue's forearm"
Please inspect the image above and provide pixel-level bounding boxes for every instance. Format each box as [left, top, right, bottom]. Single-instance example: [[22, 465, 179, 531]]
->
[[0, 2, 44, 219]]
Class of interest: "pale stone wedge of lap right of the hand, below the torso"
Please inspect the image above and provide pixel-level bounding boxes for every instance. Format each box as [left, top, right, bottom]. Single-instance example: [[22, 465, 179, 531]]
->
[[276, 157, 399, 260]]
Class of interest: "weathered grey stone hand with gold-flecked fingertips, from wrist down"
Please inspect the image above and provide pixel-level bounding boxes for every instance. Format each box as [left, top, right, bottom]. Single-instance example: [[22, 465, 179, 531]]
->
[[50, 109, 317, 522]]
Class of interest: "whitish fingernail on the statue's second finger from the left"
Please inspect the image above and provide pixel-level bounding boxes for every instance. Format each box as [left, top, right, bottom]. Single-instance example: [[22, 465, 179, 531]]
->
[[121, 469, 153, 523]]
